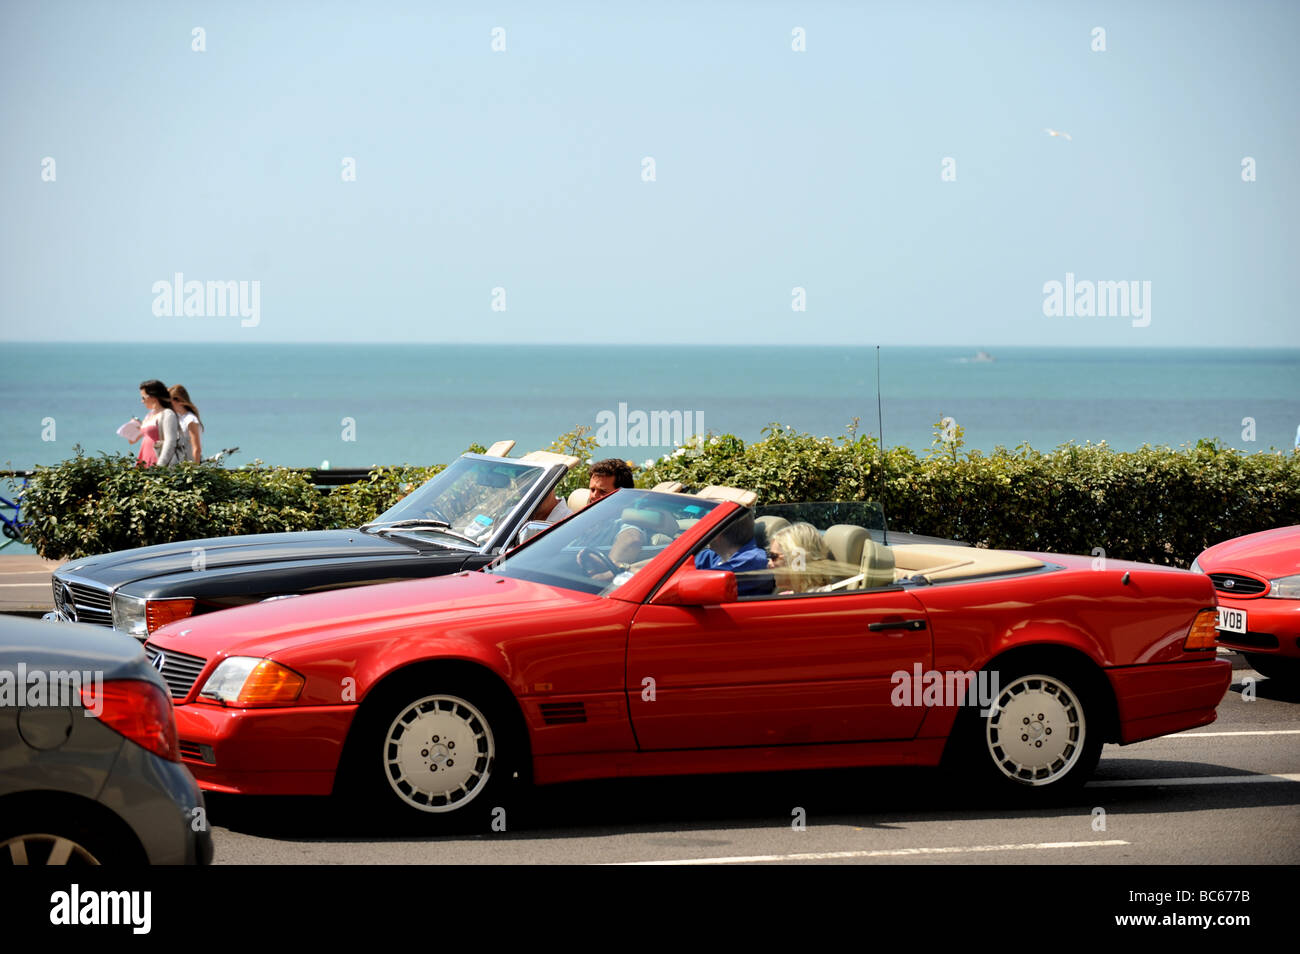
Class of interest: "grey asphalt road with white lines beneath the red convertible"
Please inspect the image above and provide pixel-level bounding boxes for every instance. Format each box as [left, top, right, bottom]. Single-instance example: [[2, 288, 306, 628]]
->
[[208, 659, 1300, 868]]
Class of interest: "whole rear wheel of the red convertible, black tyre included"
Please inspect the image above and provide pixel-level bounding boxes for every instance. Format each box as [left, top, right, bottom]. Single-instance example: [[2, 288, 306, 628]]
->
[[962, 664, 1104, 802]]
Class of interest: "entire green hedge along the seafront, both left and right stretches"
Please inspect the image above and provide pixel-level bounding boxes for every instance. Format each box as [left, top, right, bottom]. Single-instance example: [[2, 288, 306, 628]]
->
[[23, 425, 1300, 567]]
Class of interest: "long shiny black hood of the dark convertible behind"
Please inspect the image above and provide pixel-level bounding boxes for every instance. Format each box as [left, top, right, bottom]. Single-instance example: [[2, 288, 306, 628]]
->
[[57, 530, 447, 587]]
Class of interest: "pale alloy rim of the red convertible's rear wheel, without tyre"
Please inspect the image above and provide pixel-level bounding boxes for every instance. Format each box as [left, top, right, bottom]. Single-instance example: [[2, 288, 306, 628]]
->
[[984, 675, 1088, 785]]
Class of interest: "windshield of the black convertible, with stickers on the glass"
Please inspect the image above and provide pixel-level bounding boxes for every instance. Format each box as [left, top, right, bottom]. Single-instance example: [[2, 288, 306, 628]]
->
[[364, 458, 545, 547]]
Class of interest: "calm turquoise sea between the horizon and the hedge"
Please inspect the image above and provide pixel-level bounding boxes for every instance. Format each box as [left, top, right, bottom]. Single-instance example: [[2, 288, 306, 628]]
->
[[0, 343, 1300, 471]]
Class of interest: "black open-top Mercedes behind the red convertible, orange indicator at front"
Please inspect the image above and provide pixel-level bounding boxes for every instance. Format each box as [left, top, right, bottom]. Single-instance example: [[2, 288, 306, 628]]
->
[[46, 451, 577, 639]]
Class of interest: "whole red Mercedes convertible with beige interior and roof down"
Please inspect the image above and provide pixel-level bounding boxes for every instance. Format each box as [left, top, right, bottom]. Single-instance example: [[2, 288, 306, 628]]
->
[[146, 489, 1231, 828]]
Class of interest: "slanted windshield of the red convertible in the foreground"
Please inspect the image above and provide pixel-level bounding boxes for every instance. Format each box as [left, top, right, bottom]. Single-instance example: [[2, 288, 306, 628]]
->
[[488, 489, 718, 595]]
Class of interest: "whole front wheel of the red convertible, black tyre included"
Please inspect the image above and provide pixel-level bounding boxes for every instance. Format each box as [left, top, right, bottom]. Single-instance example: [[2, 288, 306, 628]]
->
[[343, 678, 519, 832]]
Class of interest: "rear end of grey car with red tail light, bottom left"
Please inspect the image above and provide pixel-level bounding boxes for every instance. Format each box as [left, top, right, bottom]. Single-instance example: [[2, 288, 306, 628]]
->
[[0, 616, 212, 867]]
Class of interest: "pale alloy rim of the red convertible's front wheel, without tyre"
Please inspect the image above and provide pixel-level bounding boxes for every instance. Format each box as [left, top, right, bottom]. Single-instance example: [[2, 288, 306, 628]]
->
[[384, 695, 497, 812]]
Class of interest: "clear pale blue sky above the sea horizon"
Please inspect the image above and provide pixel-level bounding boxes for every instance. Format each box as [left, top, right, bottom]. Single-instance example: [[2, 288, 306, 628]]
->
[[0, 1, 1300, 347]]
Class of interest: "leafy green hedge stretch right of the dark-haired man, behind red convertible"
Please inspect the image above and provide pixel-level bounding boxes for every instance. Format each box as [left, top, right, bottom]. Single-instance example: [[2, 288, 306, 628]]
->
[[638, 425, 1300, 567]]
